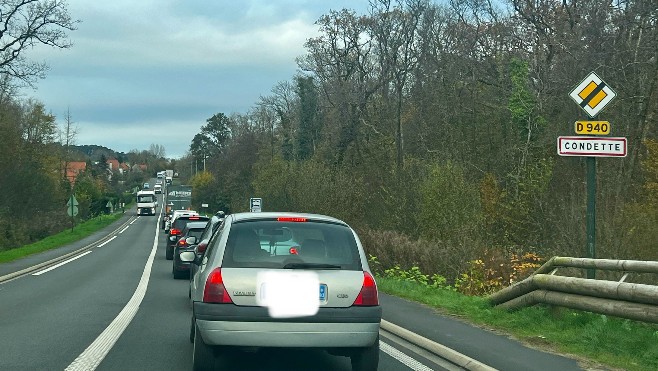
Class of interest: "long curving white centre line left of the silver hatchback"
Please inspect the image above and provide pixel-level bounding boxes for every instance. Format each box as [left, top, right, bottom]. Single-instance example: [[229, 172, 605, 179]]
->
[[66, 217, 160, 371]]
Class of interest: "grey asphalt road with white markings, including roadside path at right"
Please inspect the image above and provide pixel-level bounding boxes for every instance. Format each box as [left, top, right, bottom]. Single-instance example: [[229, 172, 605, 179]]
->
[[0, 206, 578, 371]]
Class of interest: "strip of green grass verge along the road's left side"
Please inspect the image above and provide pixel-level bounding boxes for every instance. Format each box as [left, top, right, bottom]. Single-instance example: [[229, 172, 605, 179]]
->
[[0, 213, 123, 263]]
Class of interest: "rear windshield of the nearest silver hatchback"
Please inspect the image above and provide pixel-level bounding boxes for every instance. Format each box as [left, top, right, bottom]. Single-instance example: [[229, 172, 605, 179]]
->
[[222, 220, 362, 270]]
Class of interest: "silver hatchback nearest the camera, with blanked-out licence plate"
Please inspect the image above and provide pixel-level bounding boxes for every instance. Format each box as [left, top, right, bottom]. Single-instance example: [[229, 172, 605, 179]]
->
[[180, 212, 382, 370]]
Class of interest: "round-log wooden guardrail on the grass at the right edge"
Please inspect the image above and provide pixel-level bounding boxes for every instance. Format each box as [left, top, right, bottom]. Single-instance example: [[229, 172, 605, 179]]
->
[[488, 256, 658, 323]]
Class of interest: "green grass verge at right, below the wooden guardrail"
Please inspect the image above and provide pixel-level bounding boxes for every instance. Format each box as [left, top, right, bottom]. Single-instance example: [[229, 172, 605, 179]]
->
[[377, 277, 658, 370]]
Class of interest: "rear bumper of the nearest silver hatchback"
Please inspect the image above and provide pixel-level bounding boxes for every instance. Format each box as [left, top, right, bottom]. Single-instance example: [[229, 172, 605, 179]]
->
[[194, 302, 381, 348]]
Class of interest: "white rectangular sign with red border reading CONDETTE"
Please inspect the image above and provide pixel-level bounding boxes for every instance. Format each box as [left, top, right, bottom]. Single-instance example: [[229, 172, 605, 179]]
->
[[557, 137, 627, 157]]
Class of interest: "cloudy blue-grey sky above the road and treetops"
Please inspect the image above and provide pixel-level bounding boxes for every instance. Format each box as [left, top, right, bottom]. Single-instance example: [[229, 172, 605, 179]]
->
[[25, 0, 368, 158]]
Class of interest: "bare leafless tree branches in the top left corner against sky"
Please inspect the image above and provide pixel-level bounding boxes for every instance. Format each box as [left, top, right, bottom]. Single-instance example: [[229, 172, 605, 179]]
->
[[0, 0, 78, 84]]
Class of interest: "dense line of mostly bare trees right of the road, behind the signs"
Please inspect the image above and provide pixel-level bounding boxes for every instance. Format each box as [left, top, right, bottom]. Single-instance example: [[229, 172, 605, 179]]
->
[[179, 0, 658, 286]]
